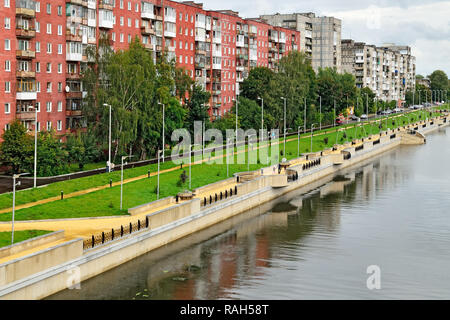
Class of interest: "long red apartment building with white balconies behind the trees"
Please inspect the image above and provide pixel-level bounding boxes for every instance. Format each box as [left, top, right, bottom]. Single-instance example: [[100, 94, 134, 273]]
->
[[0, 0, 300, 134]]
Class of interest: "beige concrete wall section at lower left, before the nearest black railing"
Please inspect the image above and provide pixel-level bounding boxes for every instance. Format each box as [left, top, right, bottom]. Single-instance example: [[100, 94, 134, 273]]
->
[[0, 239, 83, 286]]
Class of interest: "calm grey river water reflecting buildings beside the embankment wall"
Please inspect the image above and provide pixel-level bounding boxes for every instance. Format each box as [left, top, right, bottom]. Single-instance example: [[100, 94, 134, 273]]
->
[[49, 129, 450, 299]]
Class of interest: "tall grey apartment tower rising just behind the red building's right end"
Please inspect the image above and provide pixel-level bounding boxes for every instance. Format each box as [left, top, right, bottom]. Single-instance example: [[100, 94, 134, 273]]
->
[[260, 12, 342, 72]]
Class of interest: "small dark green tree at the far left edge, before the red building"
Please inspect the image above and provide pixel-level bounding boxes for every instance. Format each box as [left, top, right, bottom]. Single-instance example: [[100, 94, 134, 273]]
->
[[0, 120, 34, 174]]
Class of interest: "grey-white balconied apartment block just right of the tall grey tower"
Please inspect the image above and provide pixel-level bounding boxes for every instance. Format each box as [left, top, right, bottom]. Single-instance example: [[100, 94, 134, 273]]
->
[[342, 39, 416, 101]]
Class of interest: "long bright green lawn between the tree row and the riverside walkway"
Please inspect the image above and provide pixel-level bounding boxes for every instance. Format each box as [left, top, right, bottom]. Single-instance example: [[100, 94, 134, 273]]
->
[[0, 111, 442, 221]]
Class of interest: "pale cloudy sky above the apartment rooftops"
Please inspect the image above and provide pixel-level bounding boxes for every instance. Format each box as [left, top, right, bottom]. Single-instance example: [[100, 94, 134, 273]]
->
[[202, 0, 450, 76]]
